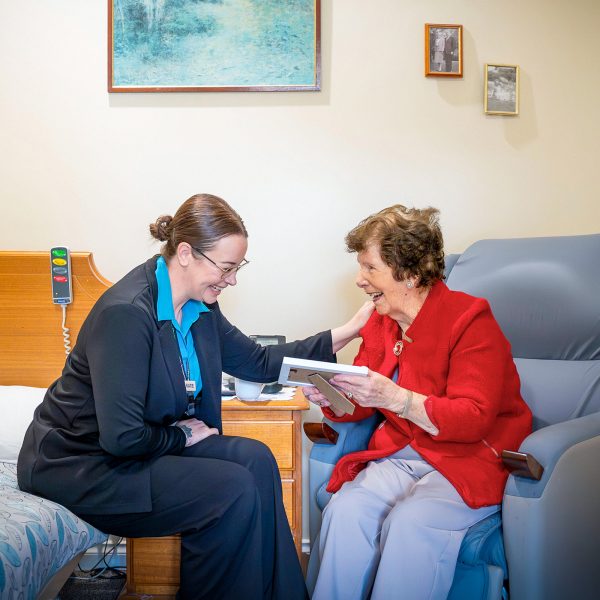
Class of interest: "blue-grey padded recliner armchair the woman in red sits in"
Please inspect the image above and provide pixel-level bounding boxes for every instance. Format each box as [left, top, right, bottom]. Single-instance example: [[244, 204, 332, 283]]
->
[[307, 234, 600, 600]]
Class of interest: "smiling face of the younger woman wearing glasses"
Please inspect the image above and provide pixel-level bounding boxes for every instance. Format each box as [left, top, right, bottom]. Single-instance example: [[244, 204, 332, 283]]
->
[[185, 235, 248, 304]]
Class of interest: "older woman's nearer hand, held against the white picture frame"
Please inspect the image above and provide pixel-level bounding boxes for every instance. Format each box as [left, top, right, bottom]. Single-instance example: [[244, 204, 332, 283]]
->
[[330, 369, 405, 412]]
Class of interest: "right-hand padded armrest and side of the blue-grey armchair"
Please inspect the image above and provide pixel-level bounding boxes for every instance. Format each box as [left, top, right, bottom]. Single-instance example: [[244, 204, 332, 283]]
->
[[502, 413, 600, 600]]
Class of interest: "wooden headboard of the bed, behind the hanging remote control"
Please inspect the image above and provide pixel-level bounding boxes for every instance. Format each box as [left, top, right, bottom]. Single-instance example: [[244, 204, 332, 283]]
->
[[0, 251, 111, 387]]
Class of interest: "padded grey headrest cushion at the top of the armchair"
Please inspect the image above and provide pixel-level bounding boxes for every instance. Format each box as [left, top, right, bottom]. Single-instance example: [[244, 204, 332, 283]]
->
[[447, 234, 600, 360]]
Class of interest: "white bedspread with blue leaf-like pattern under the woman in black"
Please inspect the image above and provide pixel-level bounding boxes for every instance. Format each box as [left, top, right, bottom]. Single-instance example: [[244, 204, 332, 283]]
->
[[0, 462, 107, 600]]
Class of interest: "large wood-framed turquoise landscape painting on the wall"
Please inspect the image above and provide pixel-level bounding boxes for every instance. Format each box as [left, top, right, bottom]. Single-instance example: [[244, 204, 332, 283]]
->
[[108, 0, 321, 92]]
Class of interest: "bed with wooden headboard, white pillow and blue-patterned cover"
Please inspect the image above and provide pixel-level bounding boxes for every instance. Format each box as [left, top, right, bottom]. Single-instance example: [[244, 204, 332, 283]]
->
[[0, 251, 110, 600]]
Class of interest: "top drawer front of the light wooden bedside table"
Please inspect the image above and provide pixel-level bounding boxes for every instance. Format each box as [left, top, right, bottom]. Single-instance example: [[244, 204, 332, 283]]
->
[[223, 421, 294, 470]]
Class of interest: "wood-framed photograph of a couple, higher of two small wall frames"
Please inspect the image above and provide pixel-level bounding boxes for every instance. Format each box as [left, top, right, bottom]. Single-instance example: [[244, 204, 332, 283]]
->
[[425, 23, 462, 77]]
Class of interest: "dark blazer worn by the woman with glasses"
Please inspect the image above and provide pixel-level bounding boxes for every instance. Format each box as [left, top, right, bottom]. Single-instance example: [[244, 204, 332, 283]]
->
[[18, 257, 335, 514]]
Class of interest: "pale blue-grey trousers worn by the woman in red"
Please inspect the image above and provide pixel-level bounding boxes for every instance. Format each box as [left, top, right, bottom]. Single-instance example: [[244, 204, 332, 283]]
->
[[312, 447, 500, 600]]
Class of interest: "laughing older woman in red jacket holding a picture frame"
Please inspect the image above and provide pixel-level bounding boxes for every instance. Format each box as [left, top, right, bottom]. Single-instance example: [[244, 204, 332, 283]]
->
[[305, 205, 531, 600]]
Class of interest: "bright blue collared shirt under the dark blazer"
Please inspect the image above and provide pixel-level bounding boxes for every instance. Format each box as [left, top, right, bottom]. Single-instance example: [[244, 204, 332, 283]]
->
[[155, 256, 209, 396]]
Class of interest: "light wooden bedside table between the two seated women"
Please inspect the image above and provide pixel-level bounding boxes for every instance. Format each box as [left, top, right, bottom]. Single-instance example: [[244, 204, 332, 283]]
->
[[121, 388, 308, 600]]
